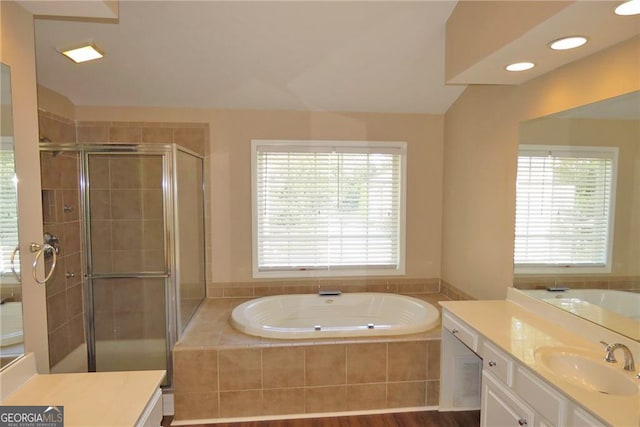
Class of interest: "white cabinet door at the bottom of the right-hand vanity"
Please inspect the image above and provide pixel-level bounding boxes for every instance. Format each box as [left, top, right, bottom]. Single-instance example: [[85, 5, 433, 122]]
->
[[480, 372, 534, 427]]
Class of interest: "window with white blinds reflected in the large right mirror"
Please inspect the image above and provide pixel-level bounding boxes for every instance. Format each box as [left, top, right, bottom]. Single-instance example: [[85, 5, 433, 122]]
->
[[514, 145, 618, 273]]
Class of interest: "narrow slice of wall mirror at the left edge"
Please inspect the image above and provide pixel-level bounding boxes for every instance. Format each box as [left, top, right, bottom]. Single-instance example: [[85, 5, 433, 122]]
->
[[0, 64, 24, 368]]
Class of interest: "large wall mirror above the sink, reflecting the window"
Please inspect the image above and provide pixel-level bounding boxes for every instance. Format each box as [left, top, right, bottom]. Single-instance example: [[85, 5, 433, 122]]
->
[[514, 91, 640, 340]]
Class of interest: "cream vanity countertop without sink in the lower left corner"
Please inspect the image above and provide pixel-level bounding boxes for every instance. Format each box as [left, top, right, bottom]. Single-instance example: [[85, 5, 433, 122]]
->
[[2, 371, 165, 427]]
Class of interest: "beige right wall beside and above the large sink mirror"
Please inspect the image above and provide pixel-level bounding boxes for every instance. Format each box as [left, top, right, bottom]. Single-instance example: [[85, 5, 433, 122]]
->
[[442, 37, 640, 299]]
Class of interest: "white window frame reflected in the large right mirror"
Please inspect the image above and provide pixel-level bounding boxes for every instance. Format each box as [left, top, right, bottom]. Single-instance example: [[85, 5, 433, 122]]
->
[[513, 144, 619, 275]]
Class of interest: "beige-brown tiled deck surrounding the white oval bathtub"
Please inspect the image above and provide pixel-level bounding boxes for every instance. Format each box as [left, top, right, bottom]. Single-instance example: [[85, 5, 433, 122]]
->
[[173, 294, 449, 422]]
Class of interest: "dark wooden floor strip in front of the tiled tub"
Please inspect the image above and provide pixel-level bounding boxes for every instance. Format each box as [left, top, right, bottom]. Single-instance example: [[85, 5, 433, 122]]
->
[[162, 411, 480, 427]]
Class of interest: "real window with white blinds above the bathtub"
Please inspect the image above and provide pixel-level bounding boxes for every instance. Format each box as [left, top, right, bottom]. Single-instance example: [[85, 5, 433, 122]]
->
[[252, 141, 406, 277]]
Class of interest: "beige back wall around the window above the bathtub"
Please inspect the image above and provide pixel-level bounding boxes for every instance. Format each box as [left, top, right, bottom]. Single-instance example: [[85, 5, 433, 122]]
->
[[76, 106, 443, 283]]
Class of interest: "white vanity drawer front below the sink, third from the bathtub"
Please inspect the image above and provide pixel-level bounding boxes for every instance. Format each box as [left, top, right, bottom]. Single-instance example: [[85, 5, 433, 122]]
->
[[513, 367, 566, 426]]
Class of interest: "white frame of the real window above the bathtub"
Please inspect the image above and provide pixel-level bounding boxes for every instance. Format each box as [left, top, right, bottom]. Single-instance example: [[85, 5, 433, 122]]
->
[[251, 139, 407, 279]]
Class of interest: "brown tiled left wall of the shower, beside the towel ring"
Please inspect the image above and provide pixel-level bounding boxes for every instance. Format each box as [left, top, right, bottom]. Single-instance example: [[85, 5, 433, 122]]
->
[[39, 111, 84, 366]]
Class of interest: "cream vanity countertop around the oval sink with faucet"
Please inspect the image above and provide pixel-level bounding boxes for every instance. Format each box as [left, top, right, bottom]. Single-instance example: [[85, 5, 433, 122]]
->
[[440, 300, 640, 427]]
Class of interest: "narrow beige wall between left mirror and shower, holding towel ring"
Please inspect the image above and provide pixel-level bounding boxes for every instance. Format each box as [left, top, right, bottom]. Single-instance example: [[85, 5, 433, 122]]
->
[[0, 0, 49, 372]]
